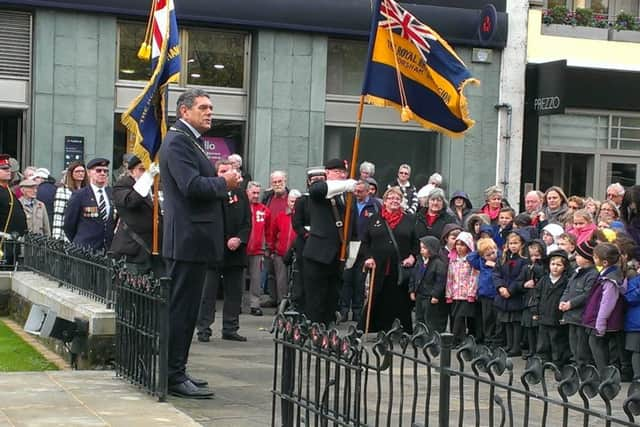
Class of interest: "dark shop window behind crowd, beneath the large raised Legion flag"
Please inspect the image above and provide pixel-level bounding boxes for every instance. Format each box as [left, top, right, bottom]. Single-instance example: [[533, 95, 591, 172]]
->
[[324, 126, 439, 191]]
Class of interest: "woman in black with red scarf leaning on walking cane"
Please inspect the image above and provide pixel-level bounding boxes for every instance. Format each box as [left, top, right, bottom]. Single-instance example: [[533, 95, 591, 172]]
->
[[361, 187, 418, 333]]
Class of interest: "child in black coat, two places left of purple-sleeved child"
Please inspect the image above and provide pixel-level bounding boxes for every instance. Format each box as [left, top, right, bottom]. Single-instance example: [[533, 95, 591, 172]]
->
[[536, 249, 570, 366]]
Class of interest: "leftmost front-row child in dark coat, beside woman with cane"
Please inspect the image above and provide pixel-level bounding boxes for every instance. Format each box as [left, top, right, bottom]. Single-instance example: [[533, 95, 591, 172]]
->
[[409, 236, 449, 333]]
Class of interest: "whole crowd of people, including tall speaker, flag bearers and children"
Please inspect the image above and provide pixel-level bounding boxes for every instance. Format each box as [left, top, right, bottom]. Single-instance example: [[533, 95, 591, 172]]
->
[[5, 89, 640, 398]]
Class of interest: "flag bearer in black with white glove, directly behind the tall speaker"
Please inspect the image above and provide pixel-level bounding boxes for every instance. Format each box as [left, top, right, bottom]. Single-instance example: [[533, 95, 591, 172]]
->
[[111, 155, 164, 277]]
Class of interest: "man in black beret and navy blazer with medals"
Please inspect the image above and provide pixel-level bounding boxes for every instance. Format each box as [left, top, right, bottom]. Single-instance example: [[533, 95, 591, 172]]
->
[[63, 158, 115, 251]]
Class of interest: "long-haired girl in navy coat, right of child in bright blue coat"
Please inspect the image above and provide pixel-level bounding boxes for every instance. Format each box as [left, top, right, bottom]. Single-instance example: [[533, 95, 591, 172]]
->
[[493, 232, 528, 357]]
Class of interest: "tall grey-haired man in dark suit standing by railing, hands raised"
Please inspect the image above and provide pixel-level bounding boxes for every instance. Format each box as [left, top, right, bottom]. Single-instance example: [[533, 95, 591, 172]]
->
[[160, 89, 239, 398]]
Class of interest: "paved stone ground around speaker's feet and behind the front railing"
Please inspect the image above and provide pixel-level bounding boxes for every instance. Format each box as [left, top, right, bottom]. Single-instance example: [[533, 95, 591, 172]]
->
[[0, 307, 626, 427]]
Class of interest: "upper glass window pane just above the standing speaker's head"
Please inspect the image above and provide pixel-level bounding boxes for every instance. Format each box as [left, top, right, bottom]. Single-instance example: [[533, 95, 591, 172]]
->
[[186, 29, 245, 88]]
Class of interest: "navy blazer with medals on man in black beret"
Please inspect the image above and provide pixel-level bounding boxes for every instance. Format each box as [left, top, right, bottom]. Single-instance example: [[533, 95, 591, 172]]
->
[[64, 185, 115, 251]]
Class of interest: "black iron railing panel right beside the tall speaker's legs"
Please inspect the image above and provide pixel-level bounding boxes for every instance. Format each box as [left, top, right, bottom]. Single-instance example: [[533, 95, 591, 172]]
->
[[115, 268, 169, 401]]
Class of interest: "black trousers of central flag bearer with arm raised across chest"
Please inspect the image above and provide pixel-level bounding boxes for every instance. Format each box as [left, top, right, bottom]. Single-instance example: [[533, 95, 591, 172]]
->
[[304, 258, 340, 325]]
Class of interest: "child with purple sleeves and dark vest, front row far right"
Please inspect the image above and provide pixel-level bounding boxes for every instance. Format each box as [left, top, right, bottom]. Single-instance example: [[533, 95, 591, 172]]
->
[[582, 243, 624, 372]]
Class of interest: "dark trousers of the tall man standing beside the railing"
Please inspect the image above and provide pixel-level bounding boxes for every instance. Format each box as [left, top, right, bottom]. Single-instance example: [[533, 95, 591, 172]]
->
[[167, 260, 207, 385]]
